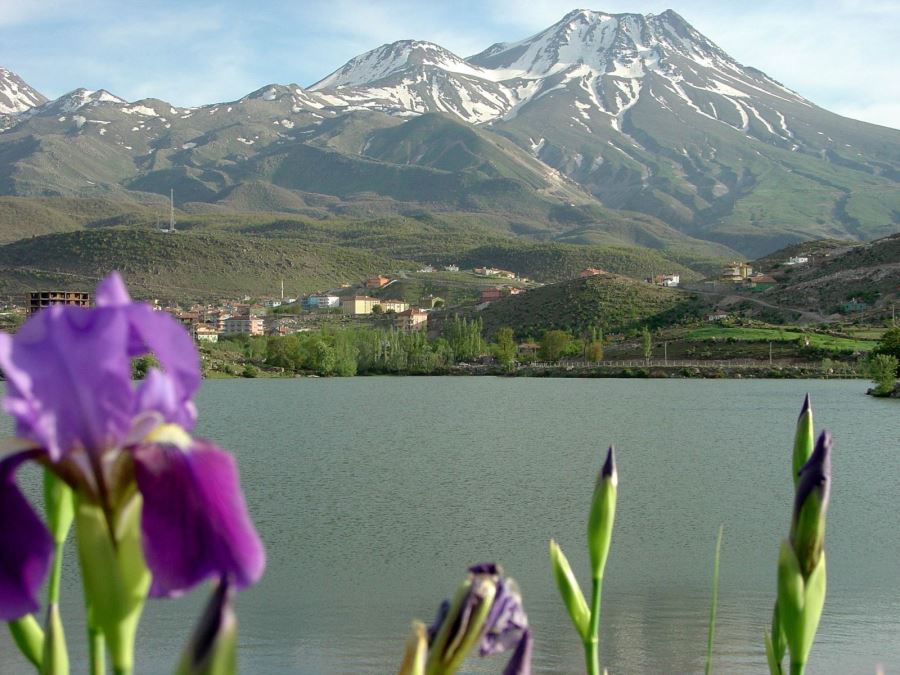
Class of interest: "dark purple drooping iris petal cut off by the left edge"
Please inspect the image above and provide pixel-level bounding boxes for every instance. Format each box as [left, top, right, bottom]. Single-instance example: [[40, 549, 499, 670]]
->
[[0, 451, 53, 621]]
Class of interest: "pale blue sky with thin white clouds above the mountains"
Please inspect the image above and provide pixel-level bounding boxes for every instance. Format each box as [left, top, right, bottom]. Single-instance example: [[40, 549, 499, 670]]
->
[[0, 0, 900, 129]]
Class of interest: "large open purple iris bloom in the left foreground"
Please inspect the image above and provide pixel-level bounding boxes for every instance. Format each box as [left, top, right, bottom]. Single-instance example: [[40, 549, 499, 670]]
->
[[0, 273, 265, 620]]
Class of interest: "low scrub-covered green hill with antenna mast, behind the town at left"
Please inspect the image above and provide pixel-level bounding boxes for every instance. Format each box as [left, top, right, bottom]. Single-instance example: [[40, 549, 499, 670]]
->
[[0, 228, 411, 299]]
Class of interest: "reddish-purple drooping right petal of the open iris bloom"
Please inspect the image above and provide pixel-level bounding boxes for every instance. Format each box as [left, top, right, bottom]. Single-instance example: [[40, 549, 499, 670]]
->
[[134, 440, 265, 597]]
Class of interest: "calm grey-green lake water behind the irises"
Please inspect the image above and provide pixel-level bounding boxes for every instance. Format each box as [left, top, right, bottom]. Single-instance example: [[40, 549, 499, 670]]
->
[[0, 377, 900, 675]]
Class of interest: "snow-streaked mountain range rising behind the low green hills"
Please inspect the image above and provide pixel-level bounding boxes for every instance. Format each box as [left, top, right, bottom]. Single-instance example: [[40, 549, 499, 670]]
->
[[0, 10, 900, 255]]
